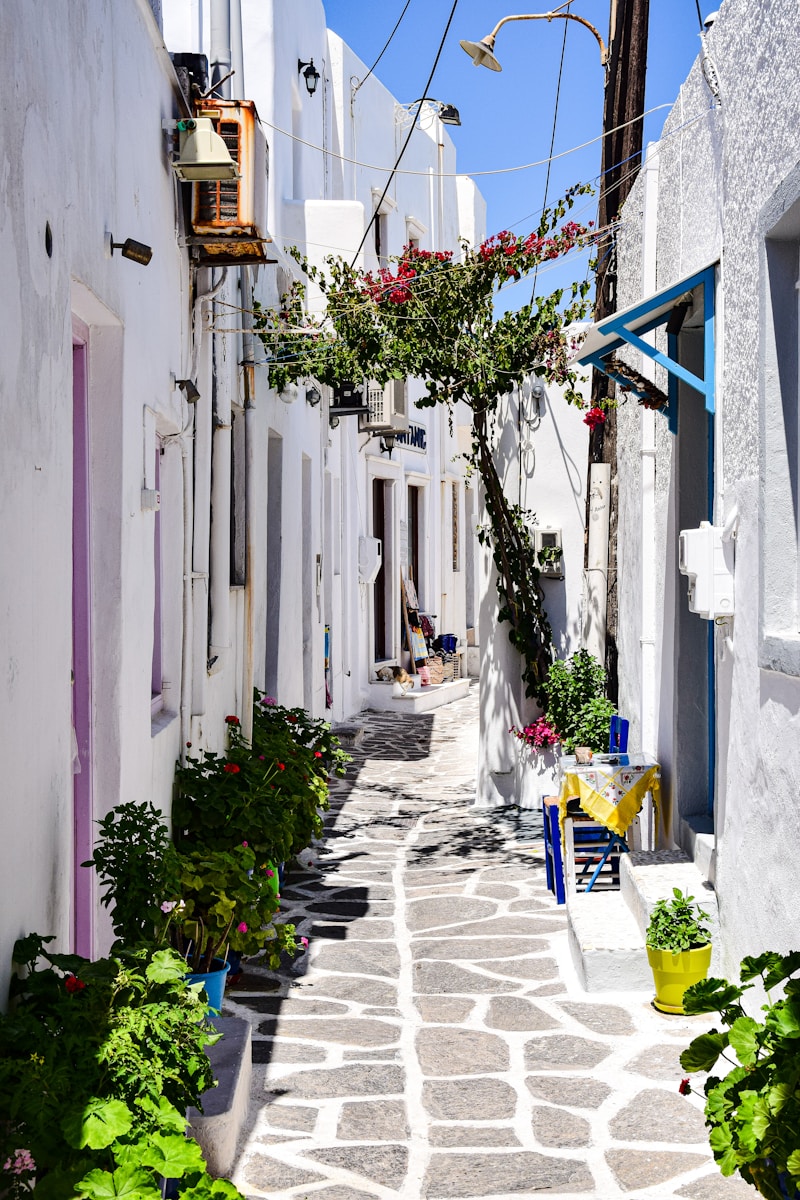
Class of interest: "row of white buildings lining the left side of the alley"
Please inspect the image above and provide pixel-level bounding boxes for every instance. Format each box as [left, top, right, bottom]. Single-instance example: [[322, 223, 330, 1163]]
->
[[0, 0, 483, 996]]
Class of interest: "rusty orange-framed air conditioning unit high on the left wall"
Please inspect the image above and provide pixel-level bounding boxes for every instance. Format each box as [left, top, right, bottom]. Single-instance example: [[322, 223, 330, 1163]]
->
[[187, 98, 272, 266]]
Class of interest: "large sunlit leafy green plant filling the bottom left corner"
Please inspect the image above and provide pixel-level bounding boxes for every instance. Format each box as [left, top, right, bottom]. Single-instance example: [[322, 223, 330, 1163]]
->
[[0, 934, 244, 1200]]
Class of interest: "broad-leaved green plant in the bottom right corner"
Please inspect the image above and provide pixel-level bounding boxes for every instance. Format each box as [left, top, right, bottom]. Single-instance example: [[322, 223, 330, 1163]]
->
[[680, 950, 800, 1200]]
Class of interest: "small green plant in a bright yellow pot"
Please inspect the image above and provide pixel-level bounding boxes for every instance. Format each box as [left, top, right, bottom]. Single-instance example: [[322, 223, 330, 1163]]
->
[[645, 888, 711, 1013]]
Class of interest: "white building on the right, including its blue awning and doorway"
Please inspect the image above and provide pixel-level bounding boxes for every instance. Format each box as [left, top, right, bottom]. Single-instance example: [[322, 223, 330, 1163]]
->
[[585, 0, 800, 972]]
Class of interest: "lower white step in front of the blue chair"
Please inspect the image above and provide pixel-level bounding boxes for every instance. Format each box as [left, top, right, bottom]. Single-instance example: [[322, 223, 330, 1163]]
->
[[566, 892, 652, 992]]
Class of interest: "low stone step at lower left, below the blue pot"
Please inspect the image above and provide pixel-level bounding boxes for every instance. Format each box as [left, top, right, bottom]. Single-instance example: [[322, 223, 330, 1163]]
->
[[186, 1016, 253, 1178]]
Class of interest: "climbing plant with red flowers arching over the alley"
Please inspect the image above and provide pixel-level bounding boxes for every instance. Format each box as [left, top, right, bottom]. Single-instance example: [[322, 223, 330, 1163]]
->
[[255, 185, 591, 697]]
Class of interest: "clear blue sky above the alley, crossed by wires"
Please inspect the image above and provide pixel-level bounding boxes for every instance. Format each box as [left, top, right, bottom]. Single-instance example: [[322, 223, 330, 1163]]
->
[[325, 0, 714, 307]]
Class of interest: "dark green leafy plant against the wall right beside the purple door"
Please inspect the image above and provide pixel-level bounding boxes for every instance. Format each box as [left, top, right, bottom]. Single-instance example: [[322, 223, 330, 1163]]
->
[[80, 804, 169, 948]]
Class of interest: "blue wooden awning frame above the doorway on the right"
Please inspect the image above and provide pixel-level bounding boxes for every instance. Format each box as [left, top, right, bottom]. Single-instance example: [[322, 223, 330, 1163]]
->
[[577, 264, 716, 433]]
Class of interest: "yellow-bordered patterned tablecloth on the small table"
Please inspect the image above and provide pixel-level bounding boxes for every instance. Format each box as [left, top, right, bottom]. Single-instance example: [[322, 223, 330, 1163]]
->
[[559, 763, 661, 836]]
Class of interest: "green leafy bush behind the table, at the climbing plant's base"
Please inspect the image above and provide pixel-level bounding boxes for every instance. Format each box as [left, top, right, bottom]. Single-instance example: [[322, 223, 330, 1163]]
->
[[542, 650, 615, 754]]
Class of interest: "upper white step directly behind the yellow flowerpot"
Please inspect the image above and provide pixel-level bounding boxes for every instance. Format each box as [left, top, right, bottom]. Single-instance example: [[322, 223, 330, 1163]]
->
[[619, 850, 721, 974]]
